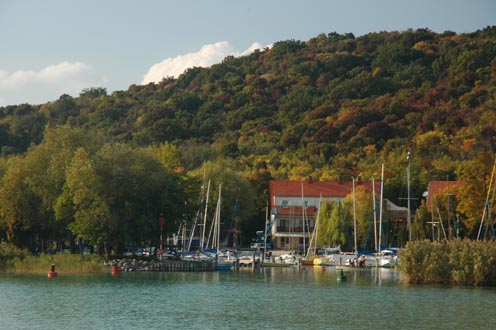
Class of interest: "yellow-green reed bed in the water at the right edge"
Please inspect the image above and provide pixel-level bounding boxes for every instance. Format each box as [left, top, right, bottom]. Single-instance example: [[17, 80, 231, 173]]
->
[[399, 240, 496, 286]]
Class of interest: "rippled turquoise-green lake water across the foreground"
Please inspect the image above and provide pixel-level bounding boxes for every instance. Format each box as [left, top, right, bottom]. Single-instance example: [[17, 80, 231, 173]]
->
[[0, 267, 496, 330]]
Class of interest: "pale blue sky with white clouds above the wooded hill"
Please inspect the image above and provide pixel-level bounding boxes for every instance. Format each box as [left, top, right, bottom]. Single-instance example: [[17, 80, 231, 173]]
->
[[0, 0, 496, 106]]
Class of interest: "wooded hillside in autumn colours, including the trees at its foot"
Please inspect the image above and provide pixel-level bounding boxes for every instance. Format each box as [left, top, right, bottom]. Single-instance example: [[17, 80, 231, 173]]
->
[[0, 27, 496, 253]]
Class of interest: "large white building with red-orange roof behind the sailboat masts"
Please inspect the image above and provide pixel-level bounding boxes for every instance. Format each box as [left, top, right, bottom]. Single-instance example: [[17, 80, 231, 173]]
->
[[269, 179, 381, 250]]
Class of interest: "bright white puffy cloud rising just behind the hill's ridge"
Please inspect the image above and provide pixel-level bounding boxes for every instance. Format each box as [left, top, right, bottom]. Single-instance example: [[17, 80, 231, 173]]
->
[[141, 41, 272, 84]]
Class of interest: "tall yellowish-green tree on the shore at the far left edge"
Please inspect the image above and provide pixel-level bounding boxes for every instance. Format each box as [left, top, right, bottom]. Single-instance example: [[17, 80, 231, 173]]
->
[[3, 126, 98, 250]]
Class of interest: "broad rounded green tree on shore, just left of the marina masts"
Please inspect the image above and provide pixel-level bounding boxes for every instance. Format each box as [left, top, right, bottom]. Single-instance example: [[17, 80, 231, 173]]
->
[[64, 144, 190, 254]]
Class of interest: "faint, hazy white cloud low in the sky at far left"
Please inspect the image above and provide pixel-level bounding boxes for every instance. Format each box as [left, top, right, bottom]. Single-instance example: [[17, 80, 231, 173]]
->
[[0, 61, 100, 106]]
